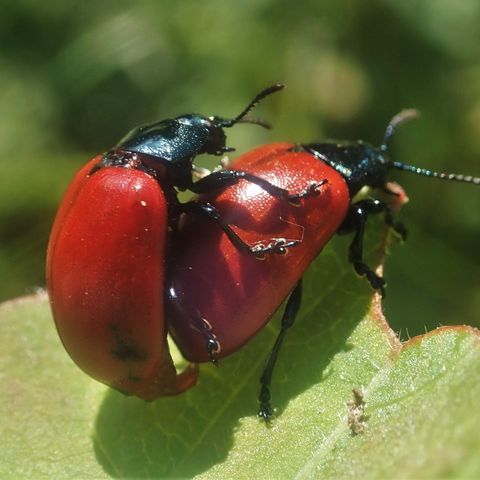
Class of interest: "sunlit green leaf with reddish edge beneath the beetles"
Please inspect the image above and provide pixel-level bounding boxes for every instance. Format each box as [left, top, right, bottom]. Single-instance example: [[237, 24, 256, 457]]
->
[[0, 238, 480, 479]]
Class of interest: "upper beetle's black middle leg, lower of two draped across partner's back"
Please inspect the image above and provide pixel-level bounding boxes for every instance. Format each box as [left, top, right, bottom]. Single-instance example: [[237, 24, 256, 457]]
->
[[181, 201, 300, 258]]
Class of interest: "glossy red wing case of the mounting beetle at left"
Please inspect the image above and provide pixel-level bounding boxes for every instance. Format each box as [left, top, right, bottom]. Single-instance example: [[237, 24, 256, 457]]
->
[[47, 156, 198, 400]]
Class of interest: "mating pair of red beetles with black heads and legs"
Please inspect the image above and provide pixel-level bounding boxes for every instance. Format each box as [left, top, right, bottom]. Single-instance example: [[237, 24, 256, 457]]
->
[[47, 85, 479, 420]]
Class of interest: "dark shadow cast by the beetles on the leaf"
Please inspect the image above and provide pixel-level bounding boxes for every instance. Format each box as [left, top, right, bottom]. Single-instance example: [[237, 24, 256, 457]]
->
[[94, 234, 378, 478]]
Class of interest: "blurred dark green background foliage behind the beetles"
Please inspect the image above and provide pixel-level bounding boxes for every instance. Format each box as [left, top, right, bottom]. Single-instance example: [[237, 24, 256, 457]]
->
[[0, 0, 480, 337]]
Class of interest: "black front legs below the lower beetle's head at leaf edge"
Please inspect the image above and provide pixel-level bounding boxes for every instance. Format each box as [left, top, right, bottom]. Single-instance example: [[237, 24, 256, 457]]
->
[[338, 198, 407, 297]]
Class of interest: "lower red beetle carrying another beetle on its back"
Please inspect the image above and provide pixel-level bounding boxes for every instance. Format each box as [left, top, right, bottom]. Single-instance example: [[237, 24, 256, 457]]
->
[[166, 110, 480, 420]]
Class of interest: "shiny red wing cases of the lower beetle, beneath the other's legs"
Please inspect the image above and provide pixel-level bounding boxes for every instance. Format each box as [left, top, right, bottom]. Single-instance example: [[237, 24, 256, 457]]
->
[[167, 143, 350, 362]]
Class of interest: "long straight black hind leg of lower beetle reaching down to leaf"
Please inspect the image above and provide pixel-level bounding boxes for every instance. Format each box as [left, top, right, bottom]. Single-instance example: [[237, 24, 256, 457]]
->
[[258, 279, 302, 423]]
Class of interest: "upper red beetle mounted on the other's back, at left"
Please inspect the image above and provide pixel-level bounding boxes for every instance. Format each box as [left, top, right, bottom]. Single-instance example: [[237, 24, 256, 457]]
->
[[47, 85, 310, 400]]
